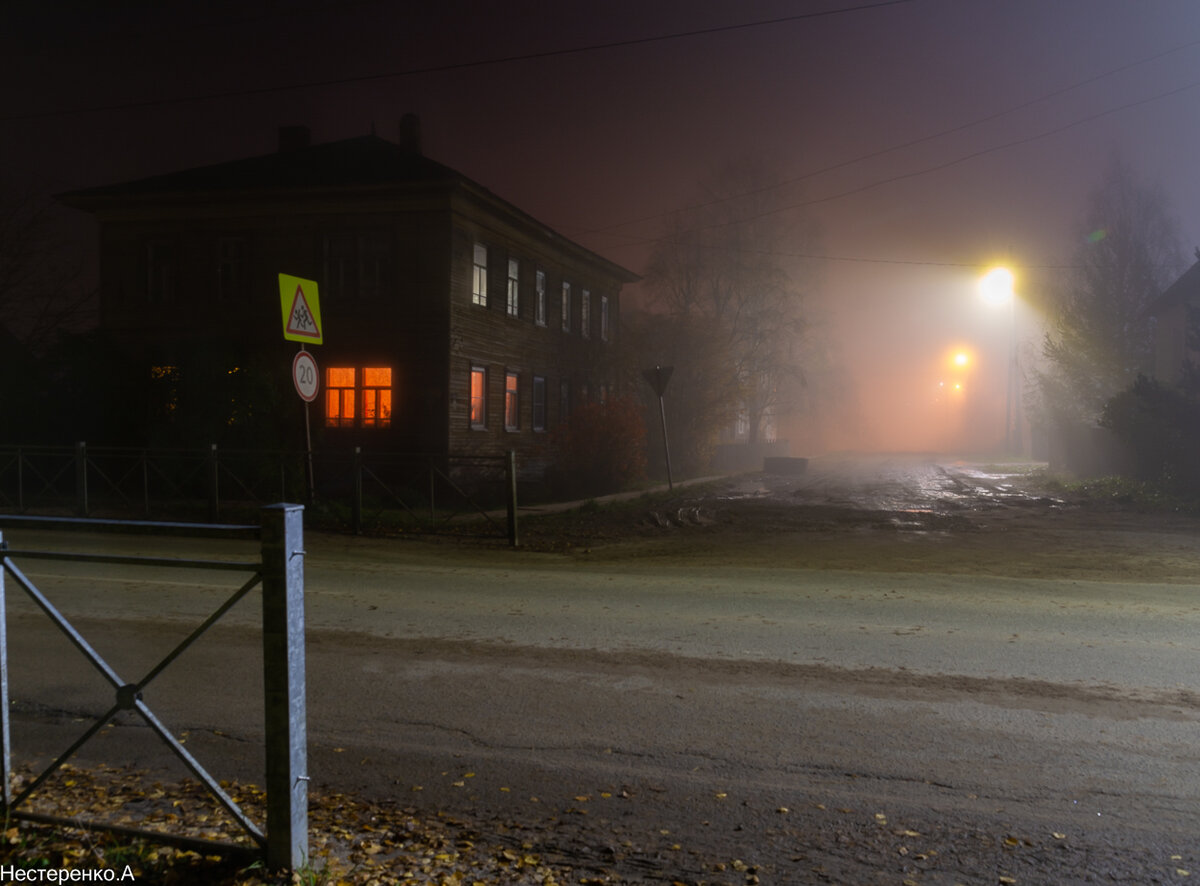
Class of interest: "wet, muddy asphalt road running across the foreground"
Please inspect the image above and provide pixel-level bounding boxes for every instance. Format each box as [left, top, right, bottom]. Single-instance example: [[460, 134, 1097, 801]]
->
[[5, 451, 1200, 884]]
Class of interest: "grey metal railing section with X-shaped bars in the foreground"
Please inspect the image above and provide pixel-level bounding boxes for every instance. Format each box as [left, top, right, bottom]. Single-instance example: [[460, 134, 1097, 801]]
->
[[0, 504, 308, 869]]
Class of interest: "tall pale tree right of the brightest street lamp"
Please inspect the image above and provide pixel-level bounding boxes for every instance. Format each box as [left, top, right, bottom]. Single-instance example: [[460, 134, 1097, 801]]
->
[[1037, 158, 1182, 424]]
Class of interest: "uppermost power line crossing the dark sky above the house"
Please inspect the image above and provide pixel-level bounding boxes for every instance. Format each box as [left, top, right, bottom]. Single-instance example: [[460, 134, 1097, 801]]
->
[[0, 0, 916, 122]]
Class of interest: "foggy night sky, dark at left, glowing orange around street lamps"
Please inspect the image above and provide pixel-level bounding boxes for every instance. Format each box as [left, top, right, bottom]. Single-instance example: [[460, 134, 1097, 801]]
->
[[9, 0, 1200, 448]]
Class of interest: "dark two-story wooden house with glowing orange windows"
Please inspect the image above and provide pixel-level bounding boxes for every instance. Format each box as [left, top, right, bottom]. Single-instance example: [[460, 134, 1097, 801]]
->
[[60, 118, 637, 482]]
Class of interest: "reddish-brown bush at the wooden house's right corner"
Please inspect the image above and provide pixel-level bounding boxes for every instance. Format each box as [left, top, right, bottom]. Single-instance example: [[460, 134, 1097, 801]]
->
[[553, 397, 646, 497]]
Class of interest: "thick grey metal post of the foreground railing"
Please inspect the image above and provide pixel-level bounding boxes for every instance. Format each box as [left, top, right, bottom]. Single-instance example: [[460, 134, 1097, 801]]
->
[[262, 504, 308, 870]]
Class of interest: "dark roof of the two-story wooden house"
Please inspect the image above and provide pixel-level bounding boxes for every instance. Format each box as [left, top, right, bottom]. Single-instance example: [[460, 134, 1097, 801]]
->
[[58, 131, 640, 282]]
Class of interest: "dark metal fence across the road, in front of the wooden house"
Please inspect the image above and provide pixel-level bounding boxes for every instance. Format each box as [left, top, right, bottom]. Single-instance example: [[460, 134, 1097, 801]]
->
[[0, 442, 517, 545]]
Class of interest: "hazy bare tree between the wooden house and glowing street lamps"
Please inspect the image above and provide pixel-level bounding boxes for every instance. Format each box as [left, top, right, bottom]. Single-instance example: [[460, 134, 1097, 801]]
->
[[647, 164, 816, 463]]
